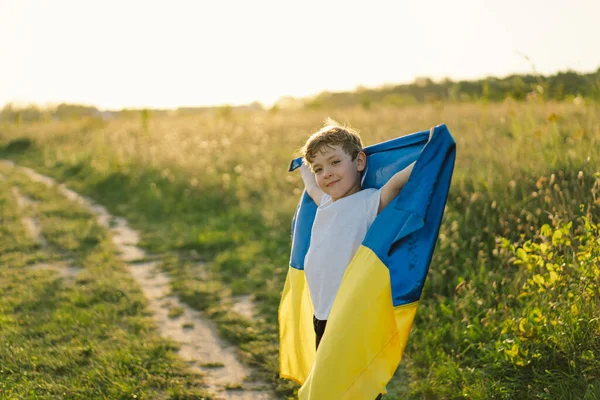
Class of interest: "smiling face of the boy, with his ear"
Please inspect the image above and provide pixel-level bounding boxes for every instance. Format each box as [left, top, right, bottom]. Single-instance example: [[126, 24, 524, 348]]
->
[[310, 146, 366, 201]]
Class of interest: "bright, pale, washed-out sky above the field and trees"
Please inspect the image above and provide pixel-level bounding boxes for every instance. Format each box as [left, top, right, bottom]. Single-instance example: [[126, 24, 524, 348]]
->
[[0, 0, 600, 109]]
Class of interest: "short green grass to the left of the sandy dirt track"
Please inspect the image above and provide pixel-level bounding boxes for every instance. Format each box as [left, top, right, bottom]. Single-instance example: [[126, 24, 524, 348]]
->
[[0, 166, 208, 399]]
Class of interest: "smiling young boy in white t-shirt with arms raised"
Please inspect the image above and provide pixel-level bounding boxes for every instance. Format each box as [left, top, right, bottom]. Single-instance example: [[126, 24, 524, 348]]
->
[[300, 119, 415, 348]]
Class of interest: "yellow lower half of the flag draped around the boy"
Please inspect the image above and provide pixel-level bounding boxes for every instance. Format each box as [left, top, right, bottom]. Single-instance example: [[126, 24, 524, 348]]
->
[[279, 246, 418, 400]]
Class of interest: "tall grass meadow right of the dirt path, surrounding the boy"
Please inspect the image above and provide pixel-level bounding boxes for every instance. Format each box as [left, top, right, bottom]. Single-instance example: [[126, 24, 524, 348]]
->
[[0, 100, 600, 399]]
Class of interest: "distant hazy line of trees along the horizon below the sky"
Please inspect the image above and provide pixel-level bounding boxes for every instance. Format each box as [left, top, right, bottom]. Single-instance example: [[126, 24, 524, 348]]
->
[[0, 68, 600, 123]]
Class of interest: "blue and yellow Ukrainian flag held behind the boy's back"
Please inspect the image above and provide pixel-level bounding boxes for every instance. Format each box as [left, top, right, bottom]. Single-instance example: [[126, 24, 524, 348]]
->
[[279, 125, 456, 400]]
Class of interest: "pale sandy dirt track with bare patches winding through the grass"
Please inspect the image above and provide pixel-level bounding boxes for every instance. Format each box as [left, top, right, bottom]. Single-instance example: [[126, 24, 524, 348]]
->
[[3, 161, 272, 400]]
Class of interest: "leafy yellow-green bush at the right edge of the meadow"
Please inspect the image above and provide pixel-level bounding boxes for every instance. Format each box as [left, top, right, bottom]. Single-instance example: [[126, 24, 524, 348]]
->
[[495, 212, 600, 398]]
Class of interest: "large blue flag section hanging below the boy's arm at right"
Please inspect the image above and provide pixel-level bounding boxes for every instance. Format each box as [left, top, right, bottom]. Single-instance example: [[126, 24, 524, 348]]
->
[[363, 125, 456, 306]]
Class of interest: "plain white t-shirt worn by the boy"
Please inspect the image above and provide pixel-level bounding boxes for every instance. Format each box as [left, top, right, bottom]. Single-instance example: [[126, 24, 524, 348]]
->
[[304, 189, 380, 320]]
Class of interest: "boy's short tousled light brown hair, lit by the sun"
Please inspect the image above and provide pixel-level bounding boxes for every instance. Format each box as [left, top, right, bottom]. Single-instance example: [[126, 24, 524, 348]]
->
[[300, 118, 363, 164]]
